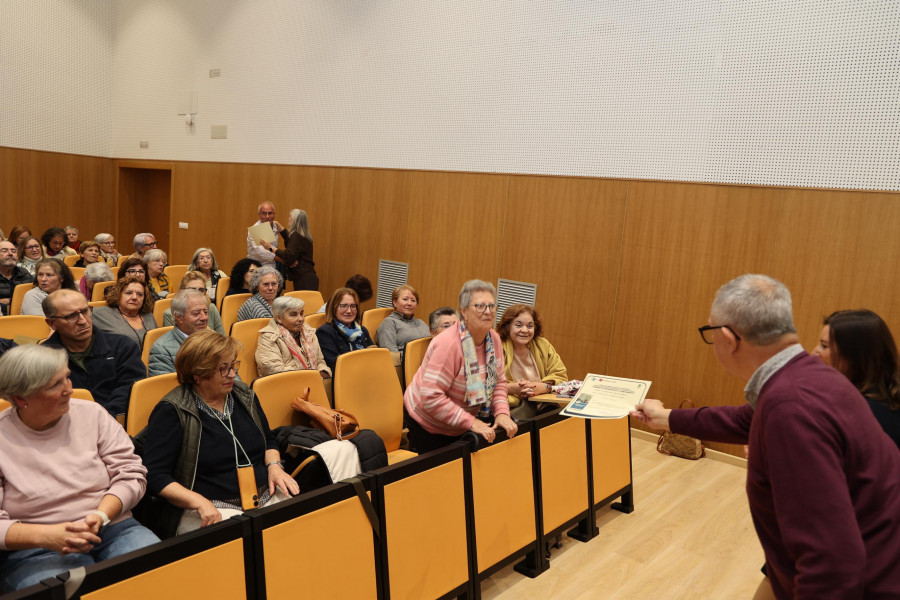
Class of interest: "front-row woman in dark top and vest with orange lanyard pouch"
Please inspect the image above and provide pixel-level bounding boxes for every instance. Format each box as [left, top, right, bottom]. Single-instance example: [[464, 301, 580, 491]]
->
[[143, 330, 300, 536]]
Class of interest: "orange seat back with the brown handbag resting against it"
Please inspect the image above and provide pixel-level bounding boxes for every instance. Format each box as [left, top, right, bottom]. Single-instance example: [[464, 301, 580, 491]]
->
[[253, 371, 330, 429]]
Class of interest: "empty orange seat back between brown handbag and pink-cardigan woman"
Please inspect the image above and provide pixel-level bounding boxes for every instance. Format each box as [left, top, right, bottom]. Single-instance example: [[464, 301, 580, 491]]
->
[[334, 348, 403, 452]]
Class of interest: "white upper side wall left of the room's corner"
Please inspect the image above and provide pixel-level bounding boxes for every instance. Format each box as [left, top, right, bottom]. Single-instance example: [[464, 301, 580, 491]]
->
[[0, 0, 114, 156]]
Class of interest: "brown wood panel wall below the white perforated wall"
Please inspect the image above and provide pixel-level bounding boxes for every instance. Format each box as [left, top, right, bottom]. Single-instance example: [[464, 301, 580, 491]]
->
[[0, 149, 900, 455]]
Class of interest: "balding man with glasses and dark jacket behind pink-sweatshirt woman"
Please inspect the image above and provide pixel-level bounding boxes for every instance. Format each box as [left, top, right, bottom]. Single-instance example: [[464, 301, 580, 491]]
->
[[42, 290, 147, 416]]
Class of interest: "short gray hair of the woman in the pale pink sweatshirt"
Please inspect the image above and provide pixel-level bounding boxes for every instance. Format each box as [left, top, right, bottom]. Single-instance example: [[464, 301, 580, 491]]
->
[[0, 344, 69, 402]]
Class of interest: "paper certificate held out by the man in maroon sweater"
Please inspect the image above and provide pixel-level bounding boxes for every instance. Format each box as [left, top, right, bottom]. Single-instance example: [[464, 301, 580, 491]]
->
[[561, 373, 651, 419]]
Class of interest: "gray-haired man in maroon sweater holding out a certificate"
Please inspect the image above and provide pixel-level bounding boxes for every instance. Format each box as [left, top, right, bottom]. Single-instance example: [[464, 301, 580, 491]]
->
[[631, 275, 900, 599]]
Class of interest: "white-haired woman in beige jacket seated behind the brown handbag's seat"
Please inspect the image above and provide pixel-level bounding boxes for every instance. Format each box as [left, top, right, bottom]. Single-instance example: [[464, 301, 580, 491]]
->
[[256, 296, 331, 378]]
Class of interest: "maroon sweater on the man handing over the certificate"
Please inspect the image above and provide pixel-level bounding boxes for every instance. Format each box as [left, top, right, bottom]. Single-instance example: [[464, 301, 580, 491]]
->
[[669, 353, 900, 600]]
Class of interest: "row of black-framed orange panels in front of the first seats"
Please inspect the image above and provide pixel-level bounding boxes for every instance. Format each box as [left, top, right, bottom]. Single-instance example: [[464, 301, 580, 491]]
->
[[10, 414, 633, 600]]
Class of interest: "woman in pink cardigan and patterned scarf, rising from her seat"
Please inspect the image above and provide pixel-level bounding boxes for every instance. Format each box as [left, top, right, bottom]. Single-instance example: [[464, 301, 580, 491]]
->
[[403, 279, 518, 454]]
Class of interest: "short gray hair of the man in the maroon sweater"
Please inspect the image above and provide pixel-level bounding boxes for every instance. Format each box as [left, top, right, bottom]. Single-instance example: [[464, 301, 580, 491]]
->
[[709, 274, 797, 346]]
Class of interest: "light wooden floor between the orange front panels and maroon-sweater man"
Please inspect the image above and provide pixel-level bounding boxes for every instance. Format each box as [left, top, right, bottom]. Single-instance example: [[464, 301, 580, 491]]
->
[[482, 432, 763, 600]]
